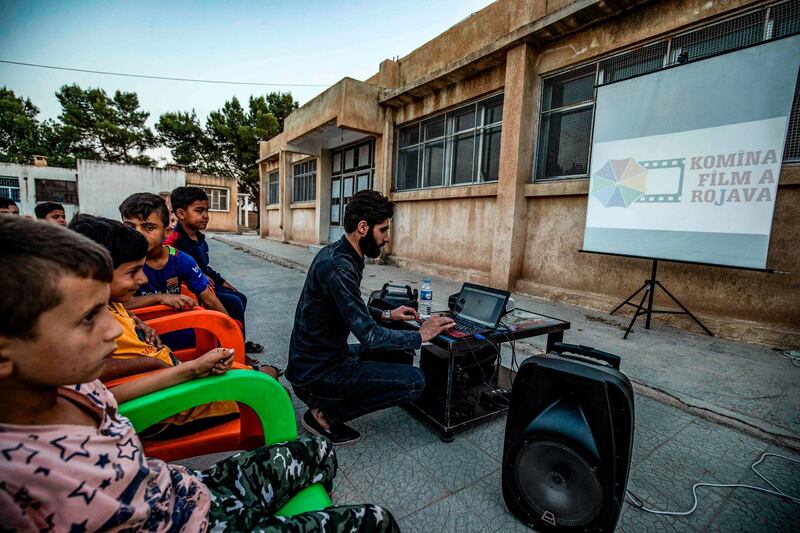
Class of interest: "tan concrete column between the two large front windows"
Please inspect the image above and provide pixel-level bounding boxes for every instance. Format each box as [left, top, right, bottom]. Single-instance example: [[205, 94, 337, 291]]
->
[[491, 44, 538, 290]]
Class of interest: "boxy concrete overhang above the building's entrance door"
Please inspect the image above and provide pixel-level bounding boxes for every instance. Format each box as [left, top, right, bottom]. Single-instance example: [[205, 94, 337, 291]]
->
[[258, 78, 384, 162]]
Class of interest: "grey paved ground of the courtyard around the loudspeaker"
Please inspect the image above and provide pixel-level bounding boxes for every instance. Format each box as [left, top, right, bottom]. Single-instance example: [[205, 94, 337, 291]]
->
[[178, 235, 800, 532]]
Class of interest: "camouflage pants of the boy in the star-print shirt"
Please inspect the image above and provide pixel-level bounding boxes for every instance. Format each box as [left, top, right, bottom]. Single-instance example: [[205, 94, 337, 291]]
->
[[196, 437, 399, 533]]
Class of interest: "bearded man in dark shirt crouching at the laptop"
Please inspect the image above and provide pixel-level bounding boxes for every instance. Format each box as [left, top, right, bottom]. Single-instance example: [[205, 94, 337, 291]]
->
[[286, 190, 453, 444]]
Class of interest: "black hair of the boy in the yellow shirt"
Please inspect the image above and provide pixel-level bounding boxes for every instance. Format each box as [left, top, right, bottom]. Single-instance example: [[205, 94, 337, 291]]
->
[[69, 215, 147, 268]]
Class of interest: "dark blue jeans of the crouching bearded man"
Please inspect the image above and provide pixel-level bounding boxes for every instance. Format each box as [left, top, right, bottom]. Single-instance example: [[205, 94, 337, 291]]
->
[[294, 344, 425, 424]]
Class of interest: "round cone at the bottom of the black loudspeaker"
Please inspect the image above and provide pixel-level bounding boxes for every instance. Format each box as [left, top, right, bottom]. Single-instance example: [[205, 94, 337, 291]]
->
[[513, 441, 603, 527]]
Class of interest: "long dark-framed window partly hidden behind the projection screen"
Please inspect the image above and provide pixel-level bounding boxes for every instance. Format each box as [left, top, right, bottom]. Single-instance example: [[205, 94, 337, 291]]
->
[[534, 0, 800, 181]]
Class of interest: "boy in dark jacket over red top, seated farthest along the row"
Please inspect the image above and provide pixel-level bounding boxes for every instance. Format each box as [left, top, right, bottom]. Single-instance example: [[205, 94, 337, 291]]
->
[[167, 187, 264, 353]]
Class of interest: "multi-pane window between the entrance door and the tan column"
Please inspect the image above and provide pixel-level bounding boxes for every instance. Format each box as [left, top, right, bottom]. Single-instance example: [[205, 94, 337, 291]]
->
[[395, 94, 503, 191]]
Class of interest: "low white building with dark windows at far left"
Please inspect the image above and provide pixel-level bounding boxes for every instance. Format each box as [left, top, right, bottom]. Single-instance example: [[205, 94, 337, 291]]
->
[[0, 162, 78, 220]]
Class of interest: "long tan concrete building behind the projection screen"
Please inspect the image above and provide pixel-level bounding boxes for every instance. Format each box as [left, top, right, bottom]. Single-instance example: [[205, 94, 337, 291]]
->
[[259, 0, 800, 346]]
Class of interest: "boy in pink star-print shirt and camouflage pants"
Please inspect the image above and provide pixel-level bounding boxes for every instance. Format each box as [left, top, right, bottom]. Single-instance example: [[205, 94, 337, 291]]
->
[[0, 217, 398, 531]]
